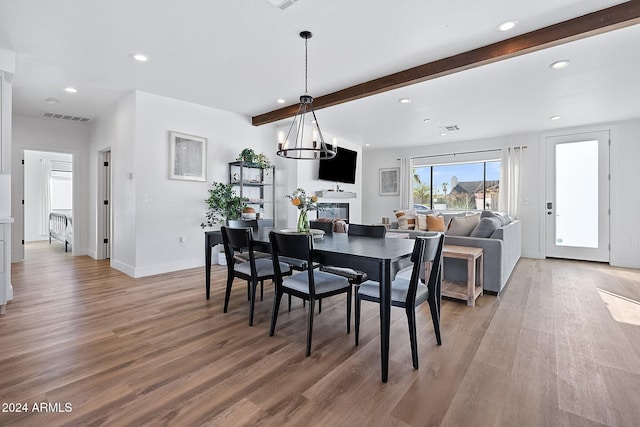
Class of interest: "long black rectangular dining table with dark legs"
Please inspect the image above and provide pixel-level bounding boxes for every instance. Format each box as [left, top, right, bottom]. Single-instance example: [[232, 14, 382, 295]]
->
[[205, 227, 414, 383]]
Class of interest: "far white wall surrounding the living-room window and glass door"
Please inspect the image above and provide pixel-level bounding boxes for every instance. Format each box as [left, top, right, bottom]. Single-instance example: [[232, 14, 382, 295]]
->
[[363, 119, 640, 268]]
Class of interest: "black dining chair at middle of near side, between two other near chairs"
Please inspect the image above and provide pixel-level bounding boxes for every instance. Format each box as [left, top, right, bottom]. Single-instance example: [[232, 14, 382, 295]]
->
[[269, 231, 351, 356]]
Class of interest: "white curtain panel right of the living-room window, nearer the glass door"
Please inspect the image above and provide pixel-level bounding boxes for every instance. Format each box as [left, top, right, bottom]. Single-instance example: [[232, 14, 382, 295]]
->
[[499, 146, 525, 219]]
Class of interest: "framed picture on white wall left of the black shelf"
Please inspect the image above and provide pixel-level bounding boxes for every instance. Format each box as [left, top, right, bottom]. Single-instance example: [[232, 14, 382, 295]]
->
[[169, 131, 207, 181]]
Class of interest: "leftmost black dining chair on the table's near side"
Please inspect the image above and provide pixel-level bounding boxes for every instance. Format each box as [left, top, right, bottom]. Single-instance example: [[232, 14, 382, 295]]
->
[[220, 226, 291, 326]]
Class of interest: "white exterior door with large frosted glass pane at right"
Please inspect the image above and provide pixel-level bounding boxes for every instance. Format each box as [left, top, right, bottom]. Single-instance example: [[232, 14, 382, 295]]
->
[[545, 131, 609, 262]]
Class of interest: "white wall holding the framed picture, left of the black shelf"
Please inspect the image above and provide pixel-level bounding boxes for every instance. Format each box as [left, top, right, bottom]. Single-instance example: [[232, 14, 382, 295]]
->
[[135, 92, 261, 276]]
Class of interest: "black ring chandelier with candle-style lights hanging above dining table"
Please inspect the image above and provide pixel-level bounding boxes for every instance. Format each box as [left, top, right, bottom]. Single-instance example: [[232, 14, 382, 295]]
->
[[277, 31, 336, 160]]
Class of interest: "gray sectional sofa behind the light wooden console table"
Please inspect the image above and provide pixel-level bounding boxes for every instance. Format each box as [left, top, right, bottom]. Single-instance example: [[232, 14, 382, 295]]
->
[[388, 212, 522, 294]]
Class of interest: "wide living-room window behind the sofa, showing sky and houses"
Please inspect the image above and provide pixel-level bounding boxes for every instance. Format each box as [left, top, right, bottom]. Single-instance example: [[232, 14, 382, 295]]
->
[[412, 160, 500, 210]]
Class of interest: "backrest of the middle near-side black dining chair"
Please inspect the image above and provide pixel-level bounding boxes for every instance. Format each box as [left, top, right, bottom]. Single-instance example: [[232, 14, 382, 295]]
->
[[269, 231, 315, 295]]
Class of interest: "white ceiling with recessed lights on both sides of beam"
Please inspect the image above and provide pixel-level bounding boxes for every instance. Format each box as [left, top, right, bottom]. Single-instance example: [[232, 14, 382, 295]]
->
[[0, 0, 640, 148]]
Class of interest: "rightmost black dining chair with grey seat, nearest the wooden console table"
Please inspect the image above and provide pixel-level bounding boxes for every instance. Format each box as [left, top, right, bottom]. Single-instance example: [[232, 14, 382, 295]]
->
[[355, 233, 444, 369]]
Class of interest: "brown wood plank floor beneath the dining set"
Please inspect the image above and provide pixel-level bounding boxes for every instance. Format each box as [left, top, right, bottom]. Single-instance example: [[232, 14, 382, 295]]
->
[[0, 243, 640, 426]]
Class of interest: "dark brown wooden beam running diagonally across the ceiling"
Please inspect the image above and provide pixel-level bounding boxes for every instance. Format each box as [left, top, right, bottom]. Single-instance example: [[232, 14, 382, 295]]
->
[[251, 0, 640, 126]]
